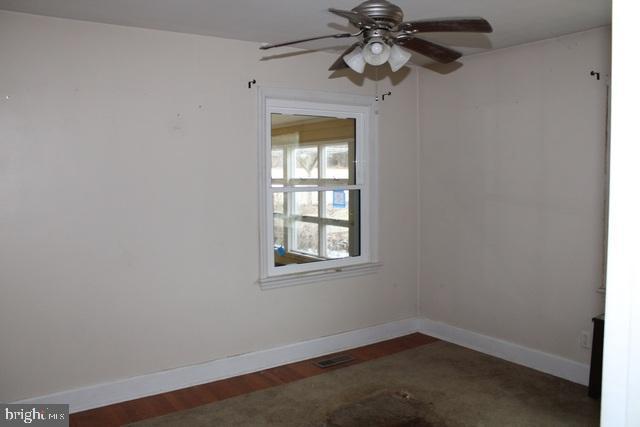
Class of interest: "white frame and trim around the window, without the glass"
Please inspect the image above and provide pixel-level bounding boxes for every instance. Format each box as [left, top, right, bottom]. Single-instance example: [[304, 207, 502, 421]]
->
[[258, 87, 380, 289]]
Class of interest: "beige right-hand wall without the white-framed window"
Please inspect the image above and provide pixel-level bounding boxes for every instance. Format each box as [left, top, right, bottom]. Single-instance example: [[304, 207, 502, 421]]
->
[[420, 28, 610, 362]]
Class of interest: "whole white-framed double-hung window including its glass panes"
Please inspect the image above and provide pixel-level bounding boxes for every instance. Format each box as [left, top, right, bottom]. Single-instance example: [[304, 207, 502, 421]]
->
[[259, 89, 378, 287]]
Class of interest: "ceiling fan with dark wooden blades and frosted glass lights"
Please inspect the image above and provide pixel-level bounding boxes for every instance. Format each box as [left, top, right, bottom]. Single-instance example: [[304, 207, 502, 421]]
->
[[260, 0, 493, 73]]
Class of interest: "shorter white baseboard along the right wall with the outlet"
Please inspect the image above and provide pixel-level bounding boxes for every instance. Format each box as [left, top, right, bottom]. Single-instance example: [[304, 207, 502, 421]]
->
[[418, 318, 589, 385]]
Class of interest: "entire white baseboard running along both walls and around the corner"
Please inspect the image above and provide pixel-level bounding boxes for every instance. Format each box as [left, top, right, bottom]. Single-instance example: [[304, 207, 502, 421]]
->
[[15, 318, 589, 413]]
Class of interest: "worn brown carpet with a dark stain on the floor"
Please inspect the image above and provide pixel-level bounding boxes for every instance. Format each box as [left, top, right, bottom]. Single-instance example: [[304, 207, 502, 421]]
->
[[130, 341, 600, 427]]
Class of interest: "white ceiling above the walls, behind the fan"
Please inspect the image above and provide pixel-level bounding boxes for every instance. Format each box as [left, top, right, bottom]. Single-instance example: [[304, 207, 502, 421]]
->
[[0, 0, 611, 58]]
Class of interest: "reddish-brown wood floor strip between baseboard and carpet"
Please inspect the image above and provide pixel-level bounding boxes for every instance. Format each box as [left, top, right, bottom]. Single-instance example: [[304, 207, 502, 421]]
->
[[70, 333, 437, 427]]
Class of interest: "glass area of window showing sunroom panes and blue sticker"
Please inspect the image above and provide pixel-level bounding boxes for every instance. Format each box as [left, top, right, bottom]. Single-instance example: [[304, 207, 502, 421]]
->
[[271, 113, 361, 267]]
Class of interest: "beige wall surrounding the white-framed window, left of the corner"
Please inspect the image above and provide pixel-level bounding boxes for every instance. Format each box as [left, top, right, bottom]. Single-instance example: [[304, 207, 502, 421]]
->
[[0, 12, 418, 401]]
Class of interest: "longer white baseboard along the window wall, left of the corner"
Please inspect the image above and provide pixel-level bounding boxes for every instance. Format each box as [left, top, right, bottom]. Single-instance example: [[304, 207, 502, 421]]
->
[[15, 318, 419, 413]]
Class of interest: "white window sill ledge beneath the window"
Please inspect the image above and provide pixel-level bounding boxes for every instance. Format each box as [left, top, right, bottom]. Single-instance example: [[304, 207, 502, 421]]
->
[[258, 262, 382, 290]]
